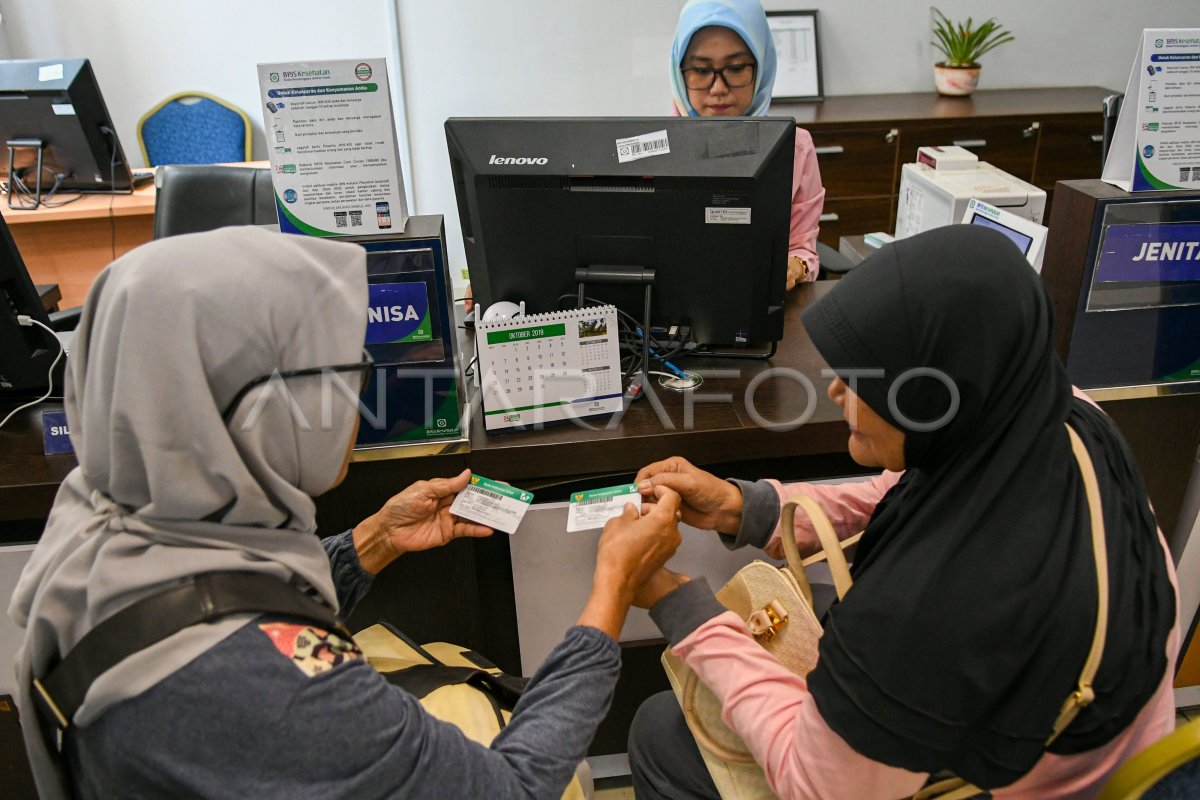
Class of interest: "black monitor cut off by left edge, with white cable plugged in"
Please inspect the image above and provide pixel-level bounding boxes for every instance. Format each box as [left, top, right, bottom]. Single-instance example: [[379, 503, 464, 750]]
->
[[0, 211, 59, 405]]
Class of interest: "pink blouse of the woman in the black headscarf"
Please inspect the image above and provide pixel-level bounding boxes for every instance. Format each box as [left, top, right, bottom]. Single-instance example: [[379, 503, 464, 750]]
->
[[674, 402, 1180, 800]]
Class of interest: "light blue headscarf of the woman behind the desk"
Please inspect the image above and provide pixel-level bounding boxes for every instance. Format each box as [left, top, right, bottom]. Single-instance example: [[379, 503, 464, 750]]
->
[[671, 0, 775, 116]]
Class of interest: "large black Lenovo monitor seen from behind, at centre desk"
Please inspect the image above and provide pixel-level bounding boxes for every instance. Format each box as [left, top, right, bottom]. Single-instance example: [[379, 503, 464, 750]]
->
[[445, 118, 796, 347]]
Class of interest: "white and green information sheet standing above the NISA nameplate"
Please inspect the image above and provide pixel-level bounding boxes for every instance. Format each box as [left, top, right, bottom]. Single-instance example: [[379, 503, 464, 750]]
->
[[258, 59, 408, 236]]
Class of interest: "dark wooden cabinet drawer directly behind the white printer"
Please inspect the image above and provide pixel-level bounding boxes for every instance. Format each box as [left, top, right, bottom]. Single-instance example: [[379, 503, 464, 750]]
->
[[896, 118, 1038, 187]]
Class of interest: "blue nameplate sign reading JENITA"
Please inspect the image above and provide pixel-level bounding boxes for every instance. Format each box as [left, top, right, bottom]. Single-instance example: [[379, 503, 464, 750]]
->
[[1094, 223, 1200, 284]]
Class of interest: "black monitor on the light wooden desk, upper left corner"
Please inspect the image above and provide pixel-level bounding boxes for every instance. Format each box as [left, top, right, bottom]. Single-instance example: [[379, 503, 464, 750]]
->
[[0, 59, 133, 194]]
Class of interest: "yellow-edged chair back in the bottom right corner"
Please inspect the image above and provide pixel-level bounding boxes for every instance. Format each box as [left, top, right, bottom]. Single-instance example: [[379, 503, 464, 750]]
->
[[1097, 720, 1200, 800]]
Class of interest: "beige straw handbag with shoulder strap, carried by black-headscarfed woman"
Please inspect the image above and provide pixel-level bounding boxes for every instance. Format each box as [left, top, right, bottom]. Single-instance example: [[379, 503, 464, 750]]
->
[[662, 426, 1109, 800]]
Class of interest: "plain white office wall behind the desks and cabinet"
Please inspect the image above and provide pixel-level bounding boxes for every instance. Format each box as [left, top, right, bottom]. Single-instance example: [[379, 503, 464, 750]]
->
[[0, 0, 1200, 284]]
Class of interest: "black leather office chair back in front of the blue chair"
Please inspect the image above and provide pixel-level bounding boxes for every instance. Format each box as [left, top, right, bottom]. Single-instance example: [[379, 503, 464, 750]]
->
[[154, 164, 278, 239]]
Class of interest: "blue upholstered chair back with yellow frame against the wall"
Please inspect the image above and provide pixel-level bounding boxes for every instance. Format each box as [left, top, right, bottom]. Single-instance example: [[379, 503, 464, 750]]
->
[[138, 91, 251, 167]]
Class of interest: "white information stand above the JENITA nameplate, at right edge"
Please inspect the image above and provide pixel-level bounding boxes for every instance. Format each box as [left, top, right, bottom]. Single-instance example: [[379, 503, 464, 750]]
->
[[1103, 28, 1200, 192]]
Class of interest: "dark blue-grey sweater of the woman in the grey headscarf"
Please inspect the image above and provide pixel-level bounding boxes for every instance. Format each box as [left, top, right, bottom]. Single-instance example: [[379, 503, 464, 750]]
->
[[66, 531, 620, 800]]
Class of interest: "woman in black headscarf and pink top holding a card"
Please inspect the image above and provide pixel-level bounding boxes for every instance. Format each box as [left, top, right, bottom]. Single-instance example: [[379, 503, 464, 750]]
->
[[629, 225, 1178, 800]]
